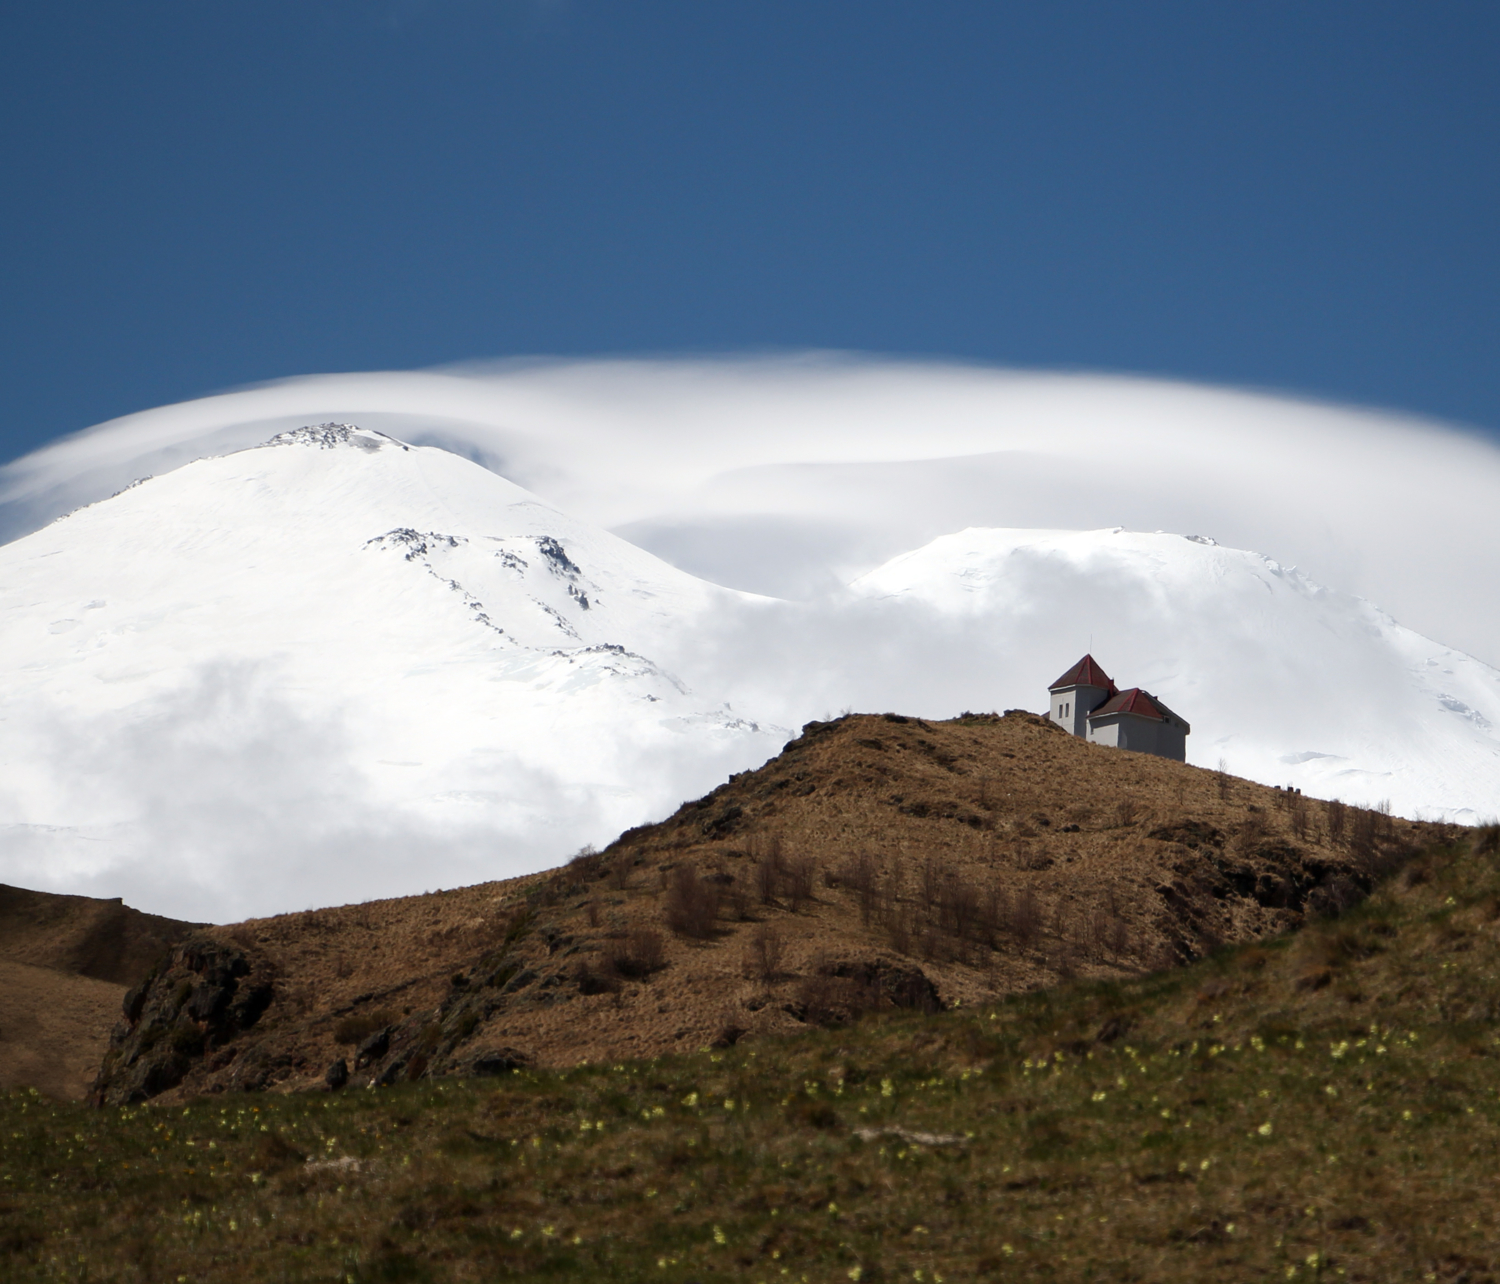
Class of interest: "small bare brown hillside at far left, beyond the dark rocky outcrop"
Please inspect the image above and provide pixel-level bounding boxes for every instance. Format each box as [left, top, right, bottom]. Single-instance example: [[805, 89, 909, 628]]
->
[[0, 884, 198, 1097]]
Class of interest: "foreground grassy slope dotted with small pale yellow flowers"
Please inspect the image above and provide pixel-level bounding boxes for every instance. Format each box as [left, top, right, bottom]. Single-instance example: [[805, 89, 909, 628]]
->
[[0, 830, 1500, 1284]]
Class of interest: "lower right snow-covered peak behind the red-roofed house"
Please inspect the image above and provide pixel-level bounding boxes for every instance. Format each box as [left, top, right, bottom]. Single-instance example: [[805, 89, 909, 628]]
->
[[852, 528, 1500, 822]]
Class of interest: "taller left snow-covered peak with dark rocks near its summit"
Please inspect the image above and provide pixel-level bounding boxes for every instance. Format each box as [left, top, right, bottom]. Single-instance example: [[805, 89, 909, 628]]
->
[[0, 425, 786, 917]]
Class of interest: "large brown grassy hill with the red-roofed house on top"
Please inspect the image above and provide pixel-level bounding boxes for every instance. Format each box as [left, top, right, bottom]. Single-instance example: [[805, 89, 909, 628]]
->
[[85, 713, 1439, 1101]]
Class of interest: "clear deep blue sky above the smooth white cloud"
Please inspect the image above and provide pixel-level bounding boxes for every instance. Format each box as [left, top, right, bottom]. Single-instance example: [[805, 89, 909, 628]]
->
[[0, 0, 1500, 458]]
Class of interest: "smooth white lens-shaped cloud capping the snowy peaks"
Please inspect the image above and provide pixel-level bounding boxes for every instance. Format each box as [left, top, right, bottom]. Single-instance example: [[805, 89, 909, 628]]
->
[[11, 356, 1500, 663]]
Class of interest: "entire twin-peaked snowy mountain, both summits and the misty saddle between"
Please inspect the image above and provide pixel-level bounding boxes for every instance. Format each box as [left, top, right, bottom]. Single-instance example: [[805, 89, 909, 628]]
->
[[0, 425, 1500, 920]]
